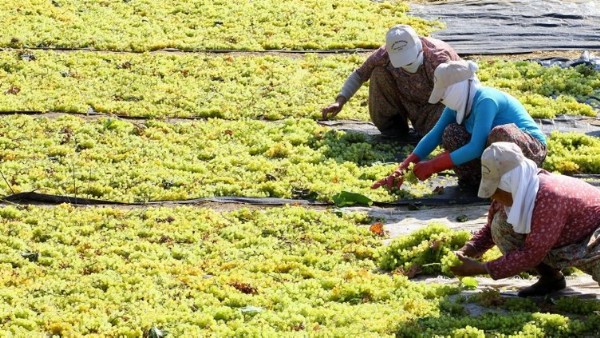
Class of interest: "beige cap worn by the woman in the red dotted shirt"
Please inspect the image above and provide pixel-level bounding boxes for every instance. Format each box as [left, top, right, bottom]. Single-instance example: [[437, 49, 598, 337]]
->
[[477, 142, 525, 198]]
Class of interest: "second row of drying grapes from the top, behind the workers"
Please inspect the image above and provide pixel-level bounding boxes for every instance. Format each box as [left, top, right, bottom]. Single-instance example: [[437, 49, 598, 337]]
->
[[0, 50, 600, 120]]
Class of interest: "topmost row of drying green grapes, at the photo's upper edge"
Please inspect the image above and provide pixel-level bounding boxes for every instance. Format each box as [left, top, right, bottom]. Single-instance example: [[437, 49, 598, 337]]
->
[[0, 0, 441, 52]]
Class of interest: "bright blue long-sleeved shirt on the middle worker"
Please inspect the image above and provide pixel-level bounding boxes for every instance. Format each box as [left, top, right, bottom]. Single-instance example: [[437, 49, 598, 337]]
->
[[414, 86, 546, 165]]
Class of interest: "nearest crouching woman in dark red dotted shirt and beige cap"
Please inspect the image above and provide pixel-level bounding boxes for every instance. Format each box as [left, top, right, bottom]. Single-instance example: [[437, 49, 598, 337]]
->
[[452, 142, 600, 297]]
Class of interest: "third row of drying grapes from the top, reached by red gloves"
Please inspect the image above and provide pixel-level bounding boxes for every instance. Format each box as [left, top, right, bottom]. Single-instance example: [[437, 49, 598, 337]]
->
[[0, 115, 600, 202]]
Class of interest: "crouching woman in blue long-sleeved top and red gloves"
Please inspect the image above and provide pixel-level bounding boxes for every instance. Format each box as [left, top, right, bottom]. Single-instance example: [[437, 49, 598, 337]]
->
[[372, 61, 546, 188]]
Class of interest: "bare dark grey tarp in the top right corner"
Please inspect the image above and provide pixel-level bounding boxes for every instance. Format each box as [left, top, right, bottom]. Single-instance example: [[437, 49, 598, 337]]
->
[[410, 0, 600, 54]]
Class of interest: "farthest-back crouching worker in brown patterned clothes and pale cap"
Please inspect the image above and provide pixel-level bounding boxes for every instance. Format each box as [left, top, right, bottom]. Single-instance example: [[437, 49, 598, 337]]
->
[[322, 25, 460, 137]]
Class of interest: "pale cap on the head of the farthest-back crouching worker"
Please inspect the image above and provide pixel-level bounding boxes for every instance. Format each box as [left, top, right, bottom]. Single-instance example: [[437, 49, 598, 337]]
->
[[385, 25, 422, 68]]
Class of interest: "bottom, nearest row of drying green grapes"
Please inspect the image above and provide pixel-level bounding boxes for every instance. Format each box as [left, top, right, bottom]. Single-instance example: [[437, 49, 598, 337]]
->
[[0, 205, 600, 337]]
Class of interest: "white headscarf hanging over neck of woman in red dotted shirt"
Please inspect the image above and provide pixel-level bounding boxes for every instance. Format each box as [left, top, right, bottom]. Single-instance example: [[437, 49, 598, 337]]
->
[[498, 158, 540, 234]]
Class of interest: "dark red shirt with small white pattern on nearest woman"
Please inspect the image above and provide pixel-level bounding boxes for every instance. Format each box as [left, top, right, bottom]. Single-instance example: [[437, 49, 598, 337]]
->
[[469, 170, 600, 279]]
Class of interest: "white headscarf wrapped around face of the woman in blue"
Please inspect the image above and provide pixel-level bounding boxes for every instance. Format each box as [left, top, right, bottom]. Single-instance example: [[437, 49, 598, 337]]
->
[[442, 61, 481, 124]]
